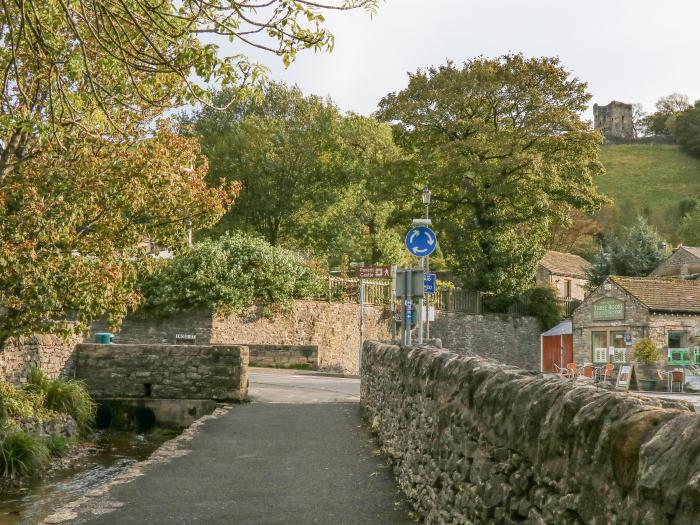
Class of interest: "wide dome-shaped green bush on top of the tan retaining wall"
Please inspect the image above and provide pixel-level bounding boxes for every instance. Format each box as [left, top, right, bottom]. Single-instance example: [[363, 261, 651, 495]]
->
[[141, 233, 322, 316]]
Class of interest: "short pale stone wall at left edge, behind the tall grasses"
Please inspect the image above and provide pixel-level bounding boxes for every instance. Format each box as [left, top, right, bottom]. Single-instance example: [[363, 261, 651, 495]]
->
[[0, 334, 82, 383]]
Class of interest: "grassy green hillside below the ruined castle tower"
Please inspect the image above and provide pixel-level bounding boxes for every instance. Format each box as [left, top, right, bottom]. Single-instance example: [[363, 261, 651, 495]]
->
[[596, 144, 700, 237]]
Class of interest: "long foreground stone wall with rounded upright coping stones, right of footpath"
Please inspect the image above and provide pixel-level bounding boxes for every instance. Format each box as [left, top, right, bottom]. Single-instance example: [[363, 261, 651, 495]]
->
[[361, 343, 700, 524]]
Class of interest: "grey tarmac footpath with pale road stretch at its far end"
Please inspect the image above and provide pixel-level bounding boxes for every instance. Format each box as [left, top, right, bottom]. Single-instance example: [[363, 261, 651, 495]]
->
[[72, 369, 413, 525]]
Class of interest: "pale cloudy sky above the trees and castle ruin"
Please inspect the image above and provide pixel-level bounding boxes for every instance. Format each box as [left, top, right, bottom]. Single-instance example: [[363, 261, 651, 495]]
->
[[222, 0, 700, 118]]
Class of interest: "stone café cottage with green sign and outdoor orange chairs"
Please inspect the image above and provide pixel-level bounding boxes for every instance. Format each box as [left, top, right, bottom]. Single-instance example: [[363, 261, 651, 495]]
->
[[573, 276, 700, 365]]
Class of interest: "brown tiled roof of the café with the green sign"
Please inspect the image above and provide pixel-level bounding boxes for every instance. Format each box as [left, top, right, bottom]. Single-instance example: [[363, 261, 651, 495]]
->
[[610, 276, 700, 313]]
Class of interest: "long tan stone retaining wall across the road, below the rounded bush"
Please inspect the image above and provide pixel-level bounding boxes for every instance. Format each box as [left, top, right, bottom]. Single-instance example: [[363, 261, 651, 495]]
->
[[92, 301, 391, 374]]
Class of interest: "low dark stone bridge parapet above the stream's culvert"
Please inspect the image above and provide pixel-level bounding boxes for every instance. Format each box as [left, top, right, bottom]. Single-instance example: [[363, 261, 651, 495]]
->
[[76, 343, 248, 401]]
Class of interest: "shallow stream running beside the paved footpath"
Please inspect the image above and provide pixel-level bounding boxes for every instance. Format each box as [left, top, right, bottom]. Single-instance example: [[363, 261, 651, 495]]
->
[[0, 429, 175, 525]]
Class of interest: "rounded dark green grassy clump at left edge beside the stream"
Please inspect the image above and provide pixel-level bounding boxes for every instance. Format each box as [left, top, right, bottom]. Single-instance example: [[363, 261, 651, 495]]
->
[[0, 431, 49, 478]]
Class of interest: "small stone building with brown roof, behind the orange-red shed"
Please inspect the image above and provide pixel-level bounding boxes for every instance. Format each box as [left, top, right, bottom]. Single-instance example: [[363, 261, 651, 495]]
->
[[536, 250, 591, 301]]
